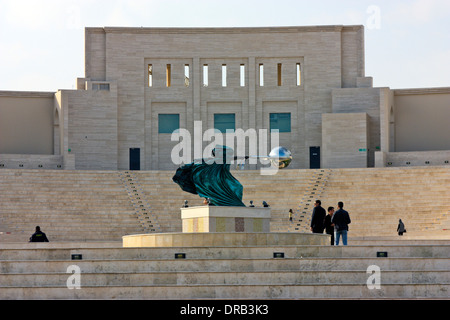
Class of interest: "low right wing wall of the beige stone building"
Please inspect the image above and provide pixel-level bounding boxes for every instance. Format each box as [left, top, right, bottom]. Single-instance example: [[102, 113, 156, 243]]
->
[[356, 88, 450, 167]]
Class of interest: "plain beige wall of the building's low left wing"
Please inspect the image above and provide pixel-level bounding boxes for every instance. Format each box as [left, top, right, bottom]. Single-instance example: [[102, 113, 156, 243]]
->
[[0, 91, 54, 155]]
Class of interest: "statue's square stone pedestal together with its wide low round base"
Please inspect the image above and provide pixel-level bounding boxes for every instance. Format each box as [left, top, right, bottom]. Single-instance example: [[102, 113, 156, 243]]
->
[[122, 206, 330, 248]]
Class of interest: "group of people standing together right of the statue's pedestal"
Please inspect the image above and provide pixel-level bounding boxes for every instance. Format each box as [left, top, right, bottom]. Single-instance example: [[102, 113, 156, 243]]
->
[[310, 200, 352, 246]]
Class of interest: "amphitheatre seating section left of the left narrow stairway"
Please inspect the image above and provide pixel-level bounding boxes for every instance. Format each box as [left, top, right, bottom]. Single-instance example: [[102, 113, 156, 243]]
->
[[0, 169, 144, 242]]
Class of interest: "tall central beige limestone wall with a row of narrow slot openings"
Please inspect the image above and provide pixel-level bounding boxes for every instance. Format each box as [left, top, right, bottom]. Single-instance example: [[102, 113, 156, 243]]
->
[[86, 26, 364, 169]]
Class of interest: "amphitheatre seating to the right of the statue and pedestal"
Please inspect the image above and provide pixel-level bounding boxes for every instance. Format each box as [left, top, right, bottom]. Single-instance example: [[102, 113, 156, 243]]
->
[[233, 167, 450, 239]]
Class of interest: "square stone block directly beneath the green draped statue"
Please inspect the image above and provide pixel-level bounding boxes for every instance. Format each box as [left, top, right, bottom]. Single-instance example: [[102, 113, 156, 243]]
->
[[181, 206, 270, 233]]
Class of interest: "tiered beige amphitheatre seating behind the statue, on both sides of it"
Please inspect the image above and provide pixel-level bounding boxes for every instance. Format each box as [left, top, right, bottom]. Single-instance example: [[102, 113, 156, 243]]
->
[[0, 167, 450, 242]]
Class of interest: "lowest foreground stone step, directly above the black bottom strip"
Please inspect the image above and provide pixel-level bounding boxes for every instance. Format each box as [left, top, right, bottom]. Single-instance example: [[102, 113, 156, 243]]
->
[[0, 284, 449, 300]]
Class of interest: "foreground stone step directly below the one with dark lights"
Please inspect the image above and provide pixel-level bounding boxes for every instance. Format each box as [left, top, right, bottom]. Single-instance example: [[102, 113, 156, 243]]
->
[[0, 257, 450, 273]]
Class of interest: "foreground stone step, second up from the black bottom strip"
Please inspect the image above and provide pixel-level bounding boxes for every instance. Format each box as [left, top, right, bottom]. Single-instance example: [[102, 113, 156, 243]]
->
[[0, 270, 450, 290]]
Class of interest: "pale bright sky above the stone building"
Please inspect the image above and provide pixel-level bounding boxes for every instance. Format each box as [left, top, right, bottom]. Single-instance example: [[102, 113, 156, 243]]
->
[[0, 0, 450, 92]]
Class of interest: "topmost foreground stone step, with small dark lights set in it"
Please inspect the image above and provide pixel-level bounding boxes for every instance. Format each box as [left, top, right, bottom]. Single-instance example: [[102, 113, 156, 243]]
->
[[0, 245, 450, 261]]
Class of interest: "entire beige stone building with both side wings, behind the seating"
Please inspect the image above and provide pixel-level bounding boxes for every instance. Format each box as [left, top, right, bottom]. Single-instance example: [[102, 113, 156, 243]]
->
[[0, 26, 450, 170]]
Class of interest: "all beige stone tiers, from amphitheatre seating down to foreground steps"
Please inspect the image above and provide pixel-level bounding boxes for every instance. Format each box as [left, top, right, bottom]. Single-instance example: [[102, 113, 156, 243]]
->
[[0, 167, 450, 299]]
